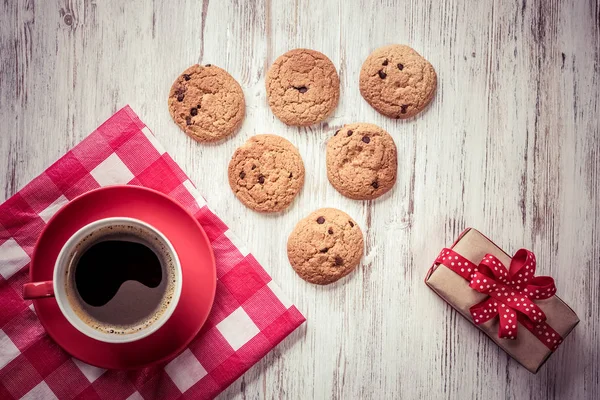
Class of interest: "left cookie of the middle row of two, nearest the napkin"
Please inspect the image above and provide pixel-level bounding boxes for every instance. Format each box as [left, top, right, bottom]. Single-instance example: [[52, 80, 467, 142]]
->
[[228, 135, 304, 212]]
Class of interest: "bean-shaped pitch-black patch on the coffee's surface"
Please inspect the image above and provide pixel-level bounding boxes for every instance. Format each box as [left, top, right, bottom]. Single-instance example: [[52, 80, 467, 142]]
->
[[75, 240, 163, 307]]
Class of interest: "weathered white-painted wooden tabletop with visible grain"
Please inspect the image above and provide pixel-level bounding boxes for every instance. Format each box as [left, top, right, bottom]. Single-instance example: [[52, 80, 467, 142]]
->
[[0, 0, 600, 399]]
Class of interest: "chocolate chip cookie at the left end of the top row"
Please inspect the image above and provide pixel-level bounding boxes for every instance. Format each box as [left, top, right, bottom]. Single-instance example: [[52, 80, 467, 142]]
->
[[169, 64, 246, 142]]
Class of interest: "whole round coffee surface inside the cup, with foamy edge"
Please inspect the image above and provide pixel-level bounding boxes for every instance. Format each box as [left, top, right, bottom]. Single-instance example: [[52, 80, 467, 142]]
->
[[65, 223, 176, 335]]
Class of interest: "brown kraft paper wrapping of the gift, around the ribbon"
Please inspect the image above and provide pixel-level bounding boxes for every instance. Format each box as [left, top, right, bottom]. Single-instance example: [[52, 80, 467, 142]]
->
[[425, 228, 579, 373]]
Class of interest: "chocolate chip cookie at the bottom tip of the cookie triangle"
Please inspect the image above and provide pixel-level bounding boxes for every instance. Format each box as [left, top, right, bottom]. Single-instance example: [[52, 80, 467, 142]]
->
[[287, 208, 364, 285]]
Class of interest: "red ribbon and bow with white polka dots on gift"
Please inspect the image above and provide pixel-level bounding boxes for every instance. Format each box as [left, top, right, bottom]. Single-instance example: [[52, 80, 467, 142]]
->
[[436, 249, 563, 351]]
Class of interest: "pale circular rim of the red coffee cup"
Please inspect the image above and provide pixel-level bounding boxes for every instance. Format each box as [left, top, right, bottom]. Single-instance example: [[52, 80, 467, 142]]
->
[[52, 217, 182, 343]]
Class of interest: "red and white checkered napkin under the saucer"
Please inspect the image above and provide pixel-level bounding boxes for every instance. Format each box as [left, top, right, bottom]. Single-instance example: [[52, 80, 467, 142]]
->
[[0, 107, 304, 400]]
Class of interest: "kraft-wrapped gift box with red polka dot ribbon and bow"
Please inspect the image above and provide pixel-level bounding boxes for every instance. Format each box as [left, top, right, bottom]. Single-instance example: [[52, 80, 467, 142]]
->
[[425, 228, 579, 373]]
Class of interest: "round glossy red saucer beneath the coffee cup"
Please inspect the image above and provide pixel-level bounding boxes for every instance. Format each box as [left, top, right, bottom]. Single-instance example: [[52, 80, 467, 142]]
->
[[30, 186, 216, 369]]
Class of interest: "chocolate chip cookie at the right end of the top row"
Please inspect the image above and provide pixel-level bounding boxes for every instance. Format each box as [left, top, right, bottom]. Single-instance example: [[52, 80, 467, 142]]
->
[[359, 44, 437, 119]]
